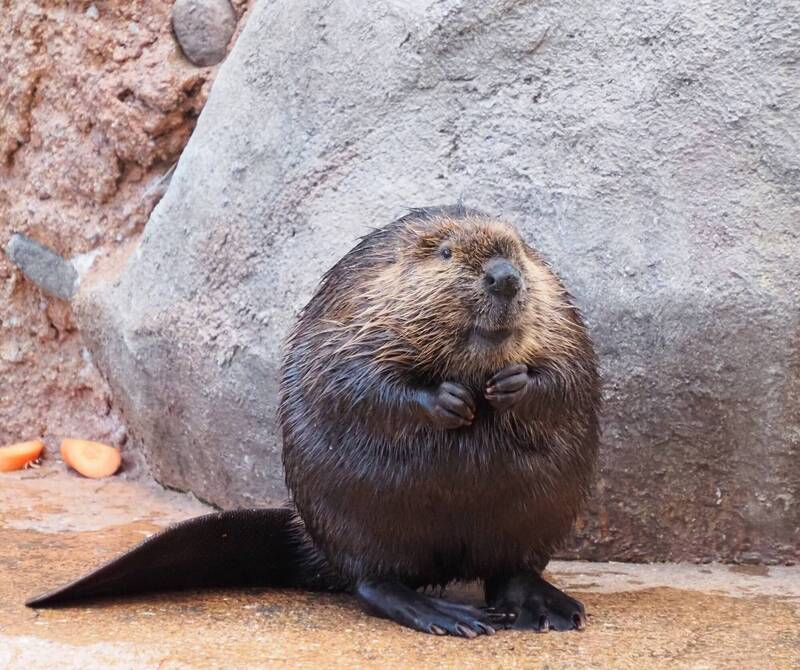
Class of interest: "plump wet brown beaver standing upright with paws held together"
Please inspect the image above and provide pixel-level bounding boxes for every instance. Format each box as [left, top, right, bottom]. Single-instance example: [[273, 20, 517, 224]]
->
[[28, 205, 600, 638]]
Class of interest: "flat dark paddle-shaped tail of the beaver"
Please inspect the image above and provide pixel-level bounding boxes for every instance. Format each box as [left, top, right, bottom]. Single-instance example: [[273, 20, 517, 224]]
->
[[25, 508, 337, 608]]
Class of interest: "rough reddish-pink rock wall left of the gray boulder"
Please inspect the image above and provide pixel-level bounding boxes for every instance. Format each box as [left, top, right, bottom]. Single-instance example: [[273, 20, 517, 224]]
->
[[0, 0, 250, 462]]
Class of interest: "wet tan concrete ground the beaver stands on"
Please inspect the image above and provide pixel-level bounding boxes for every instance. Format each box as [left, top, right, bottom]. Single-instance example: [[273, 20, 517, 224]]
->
[[0, 464, 800, 670]]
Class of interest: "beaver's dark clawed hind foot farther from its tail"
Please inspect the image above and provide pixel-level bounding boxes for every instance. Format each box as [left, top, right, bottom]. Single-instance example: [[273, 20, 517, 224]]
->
[[486, 574, 586, 633]]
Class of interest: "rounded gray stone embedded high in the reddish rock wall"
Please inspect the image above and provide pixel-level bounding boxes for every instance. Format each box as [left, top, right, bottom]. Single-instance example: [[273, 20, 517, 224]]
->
[[172, 0, 236, 66]]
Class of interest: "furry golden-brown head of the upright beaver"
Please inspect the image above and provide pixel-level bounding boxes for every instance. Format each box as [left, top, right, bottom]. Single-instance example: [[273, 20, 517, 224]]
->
[[339, 208, 573, 380]]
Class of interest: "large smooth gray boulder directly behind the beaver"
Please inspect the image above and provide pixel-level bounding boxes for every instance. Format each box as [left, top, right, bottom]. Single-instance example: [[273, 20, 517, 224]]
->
[[72, 0, 800, 561]]
